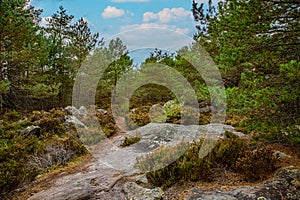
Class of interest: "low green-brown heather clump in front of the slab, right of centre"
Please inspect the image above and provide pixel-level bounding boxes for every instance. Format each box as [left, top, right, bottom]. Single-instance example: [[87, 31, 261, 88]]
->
[[142, 136, 277, 187]]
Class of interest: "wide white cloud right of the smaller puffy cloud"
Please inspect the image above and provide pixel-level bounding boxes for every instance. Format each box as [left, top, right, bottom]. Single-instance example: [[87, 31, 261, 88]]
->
[[143, 7, 191, 23]]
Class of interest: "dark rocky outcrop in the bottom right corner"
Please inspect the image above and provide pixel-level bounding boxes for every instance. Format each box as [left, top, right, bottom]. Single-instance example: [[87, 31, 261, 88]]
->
[[187, 166, 300, 200]]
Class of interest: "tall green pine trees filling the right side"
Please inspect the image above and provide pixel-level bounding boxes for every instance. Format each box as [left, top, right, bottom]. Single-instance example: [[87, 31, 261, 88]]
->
[[192, 0, 300, 143]]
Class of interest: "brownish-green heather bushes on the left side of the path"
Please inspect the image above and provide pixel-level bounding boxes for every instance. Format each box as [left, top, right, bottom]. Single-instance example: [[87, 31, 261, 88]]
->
[[0, 109, 87, 195]]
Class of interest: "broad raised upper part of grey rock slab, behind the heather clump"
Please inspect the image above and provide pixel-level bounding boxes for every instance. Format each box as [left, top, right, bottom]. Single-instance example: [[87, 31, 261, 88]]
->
[[101, 123, 242, 172]]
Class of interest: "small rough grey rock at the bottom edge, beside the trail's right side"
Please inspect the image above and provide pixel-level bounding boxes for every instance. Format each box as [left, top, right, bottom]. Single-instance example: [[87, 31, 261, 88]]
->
[[123, 182, 164, 200]]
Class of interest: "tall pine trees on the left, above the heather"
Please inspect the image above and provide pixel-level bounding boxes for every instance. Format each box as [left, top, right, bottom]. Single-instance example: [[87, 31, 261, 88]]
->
[[0, 0, 101, 110]]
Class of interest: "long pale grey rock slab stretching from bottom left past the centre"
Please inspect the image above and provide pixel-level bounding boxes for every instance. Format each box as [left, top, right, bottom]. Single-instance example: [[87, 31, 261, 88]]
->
[[30, 123, 241, 200]]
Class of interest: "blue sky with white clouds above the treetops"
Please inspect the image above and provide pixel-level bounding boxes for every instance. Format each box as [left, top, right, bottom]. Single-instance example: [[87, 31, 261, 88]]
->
[[30, 0, 214, 60]]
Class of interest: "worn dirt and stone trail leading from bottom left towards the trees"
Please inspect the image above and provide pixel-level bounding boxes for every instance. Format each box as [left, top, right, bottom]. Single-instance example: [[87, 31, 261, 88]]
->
[[13, 118, 129, 200]]
